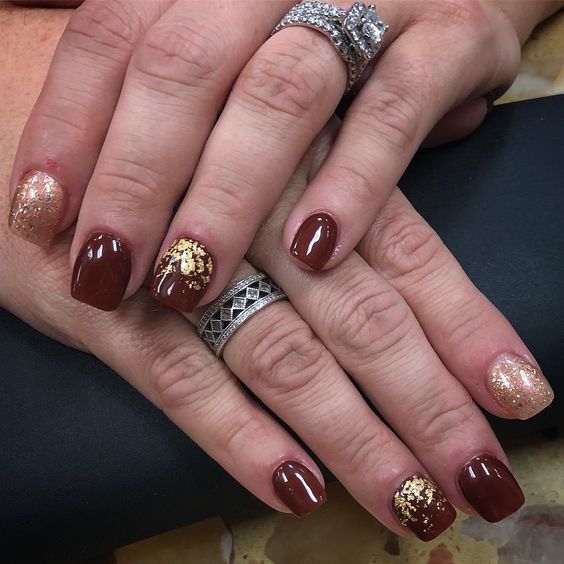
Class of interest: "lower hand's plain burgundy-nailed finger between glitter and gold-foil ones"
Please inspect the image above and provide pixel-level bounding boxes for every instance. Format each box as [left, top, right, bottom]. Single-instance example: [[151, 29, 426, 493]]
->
[[249, 149, 523, 521]]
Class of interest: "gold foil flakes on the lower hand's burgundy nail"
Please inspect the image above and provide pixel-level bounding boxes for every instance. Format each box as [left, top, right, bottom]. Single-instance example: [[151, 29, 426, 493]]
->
[[393, 476, 447, 526]]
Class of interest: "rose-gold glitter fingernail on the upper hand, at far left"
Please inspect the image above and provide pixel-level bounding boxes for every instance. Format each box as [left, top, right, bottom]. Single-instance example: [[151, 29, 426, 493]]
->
[[8, 170, 65, 247]]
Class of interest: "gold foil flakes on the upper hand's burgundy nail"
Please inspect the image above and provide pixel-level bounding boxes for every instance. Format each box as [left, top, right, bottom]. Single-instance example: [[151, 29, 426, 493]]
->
[[157, 238, 214, 290]]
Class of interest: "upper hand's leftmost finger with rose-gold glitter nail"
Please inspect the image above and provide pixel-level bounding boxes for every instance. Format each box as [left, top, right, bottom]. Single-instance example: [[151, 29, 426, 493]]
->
[[10, 0, 172, 246]]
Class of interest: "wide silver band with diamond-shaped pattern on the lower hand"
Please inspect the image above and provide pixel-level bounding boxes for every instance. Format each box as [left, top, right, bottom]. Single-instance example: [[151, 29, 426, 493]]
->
[[198, 272, 286, 358]]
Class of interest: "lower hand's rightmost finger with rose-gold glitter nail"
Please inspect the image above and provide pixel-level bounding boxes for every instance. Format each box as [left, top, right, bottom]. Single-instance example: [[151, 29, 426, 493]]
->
[[359, 190, 554, 419]]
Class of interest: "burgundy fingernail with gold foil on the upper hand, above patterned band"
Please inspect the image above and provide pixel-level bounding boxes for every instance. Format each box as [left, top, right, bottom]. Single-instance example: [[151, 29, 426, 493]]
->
[[152, 238, 214, 313]]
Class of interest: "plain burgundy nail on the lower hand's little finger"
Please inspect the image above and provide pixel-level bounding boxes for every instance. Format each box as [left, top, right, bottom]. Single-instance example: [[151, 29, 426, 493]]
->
[[272, 461, 327, 517]]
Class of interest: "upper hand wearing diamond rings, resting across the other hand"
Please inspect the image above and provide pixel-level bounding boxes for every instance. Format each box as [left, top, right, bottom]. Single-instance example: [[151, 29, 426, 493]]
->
[[7, 0, 558, 312]]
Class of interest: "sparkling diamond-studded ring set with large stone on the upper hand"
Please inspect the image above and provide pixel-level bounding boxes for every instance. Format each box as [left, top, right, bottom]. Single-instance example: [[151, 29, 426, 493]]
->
[[272, 0, 390, 92]]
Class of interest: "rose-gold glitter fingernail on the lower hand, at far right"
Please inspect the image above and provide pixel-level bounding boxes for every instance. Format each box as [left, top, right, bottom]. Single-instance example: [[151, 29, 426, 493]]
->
[[488, 354, 554, 419]]
